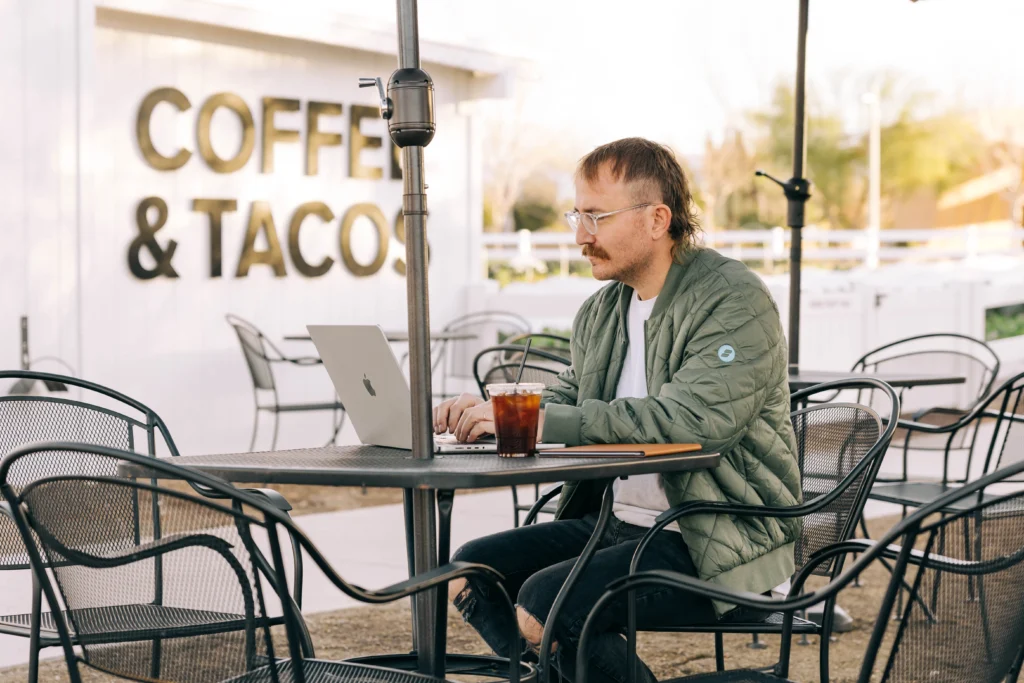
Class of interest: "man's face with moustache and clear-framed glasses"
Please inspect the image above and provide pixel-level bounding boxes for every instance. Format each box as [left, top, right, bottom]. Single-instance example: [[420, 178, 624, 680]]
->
[[575, 165, 653, 284]]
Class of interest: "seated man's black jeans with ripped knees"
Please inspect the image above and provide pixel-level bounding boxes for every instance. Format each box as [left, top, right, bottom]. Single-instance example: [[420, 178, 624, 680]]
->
[[453, 515, 715, 683]]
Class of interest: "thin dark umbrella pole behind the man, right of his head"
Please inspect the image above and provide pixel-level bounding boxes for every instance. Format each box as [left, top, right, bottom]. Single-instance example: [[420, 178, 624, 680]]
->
[[756, 0, 811, 375]]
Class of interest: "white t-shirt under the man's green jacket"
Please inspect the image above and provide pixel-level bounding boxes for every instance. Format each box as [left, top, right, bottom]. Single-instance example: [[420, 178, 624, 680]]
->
[[611, 291, 679, 531]]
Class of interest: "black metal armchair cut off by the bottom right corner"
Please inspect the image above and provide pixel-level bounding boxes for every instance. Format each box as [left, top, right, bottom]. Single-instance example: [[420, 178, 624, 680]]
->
[[581, 461, 1024, 683]]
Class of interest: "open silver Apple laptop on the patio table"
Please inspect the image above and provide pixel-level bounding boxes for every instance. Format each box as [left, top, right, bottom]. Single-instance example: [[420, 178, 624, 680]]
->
[[306, 325, 564, 454]]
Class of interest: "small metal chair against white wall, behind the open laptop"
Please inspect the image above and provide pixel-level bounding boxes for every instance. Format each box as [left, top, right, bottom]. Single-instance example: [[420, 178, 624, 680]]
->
[[224, 314, 345, 451]]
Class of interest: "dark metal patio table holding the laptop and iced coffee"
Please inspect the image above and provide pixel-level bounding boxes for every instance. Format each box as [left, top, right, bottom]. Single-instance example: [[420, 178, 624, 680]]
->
[[120, 445, 720, 677]]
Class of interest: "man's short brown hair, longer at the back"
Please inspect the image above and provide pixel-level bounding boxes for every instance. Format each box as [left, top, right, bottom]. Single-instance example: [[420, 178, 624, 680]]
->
[[577, 137, 700, 256]]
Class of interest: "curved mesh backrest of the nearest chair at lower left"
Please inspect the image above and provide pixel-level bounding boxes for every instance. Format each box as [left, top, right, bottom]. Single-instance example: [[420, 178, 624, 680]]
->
[[0, 443, 284, 683]]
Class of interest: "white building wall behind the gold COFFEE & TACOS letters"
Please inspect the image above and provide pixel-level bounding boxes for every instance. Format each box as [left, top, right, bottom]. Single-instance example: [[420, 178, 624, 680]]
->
[[0, 0, 493, 453]]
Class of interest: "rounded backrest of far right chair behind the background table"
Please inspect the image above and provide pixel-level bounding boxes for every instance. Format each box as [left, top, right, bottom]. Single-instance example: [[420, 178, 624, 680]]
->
[[853, 333, 999, 409]]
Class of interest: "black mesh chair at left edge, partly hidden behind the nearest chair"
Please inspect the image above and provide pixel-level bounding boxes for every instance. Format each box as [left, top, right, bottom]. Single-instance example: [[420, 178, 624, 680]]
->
[[0, 371, 302, 682]]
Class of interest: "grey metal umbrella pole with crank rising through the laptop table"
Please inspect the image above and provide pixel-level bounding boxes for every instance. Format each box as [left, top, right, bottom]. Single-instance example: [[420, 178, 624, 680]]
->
[[359, 0, 445, 677]]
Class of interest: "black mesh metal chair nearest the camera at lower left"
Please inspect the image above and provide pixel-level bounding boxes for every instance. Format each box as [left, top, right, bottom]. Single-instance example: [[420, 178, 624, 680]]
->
[[0, 442, 532, 683]]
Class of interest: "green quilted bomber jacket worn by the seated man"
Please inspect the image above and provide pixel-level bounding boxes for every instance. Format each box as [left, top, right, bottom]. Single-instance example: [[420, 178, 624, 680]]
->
[[542, 249, 801, 613]]
